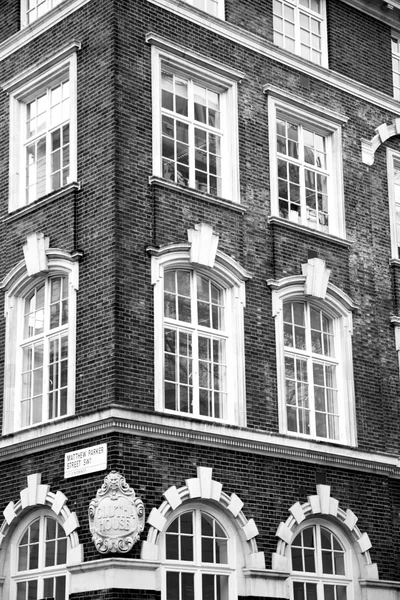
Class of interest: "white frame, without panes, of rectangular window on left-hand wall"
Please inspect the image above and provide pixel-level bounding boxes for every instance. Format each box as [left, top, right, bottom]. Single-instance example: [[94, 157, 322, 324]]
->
[[3, 48, 78, 212]]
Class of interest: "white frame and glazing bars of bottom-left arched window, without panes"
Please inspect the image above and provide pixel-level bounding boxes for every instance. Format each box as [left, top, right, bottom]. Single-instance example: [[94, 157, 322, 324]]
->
[[10, 507, 71, 600]]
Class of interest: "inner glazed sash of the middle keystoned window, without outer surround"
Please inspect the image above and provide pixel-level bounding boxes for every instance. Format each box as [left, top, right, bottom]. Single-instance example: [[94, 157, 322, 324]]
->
[[164, 269, 228, 419]]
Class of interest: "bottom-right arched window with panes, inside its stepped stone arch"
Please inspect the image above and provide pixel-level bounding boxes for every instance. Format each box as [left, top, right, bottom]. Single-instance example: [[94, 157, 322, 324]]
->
[[290, 522, 353, 600]]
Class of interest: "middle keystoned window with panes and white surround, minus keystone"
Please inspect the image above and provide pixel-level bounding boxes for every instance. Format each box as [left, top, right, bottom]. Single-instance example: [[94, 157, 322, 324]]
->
[[152, 230, 247, 425]]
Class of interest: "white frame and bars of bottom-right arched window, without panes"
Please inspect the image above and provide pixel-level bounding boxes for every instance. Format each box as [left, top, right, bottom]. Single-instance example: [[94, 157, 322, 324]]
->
[[287, 518, 360, 600]]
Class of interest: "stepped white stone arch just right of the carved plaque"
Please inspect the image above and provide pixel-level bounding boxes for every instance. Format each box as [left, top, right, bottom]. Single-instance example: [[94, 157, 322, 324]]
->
[[141, 467, 265, 569]]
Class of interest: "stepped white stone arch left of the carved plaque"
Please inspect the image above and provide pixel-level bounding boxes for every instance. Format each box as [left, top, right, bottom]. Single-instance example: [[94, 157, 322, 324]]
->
[[0, 473, 83, 564]]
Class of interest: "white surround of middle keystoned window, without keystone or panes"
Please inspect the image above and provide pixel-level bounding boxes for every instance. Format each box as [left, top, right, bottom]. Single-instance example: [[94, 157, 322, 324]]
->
[[152, 245, 246, 426]]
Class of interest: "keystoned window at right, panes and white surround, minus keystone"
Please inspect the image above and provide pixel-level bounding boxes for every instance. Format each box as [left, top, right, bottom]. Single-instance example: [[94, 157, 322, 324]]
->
[[273, 267, 356, 445]]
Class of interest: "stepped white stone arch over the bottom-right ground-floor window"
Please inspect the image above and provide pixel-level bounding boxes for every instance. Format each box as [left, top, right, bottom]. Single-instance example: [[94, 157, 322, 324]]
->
[[272, 485, 379, 579]]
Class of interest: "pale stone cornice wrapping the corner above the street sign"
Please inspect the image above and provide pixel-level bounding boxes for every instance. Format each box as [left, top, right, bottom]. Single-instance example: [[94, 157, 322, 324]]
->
[[0, 406, 400, 479]]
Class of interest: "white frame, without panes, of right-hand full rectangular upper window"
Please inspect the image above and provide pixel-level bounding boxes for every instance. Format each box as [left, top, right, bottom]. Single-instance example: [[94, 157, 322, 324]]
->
[[264, 86, 347, 238]]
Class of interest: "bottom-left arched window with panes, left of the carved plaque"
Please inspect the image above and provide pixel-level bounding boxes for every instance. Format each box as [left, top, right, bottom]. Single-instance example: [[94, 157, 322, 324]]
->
[[10, 513, 68, 600]]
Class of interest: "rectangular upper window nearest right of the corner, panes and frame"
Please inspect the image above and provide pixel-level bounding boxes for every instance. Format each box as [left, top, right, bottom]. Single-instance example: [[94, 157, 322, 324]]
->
[[153, 41, 239, 201]]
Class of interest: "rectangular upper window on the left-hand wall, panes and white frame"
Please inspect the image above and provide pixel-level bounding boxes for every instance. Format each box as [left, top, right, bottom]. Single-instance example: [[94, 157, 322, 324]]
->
[[5, 47, 76, 210]]
